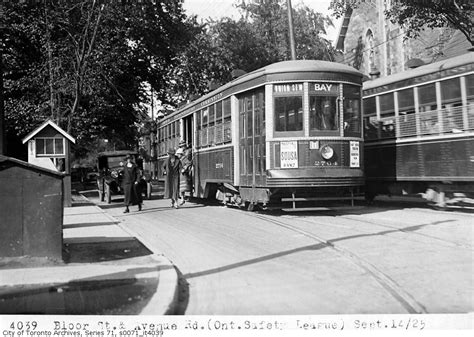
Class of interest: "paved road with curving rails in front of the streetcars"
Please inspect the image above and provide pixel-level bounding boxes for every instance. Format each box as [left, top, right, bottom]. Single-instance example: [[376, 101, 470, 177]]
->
[[90, 194, 474, 315]]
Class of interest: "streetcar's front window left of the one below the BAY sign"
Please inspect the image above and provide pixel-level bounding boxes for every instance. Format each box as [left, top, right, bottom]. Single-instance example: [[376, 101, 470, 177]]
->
[[275, 96, 303, 131]]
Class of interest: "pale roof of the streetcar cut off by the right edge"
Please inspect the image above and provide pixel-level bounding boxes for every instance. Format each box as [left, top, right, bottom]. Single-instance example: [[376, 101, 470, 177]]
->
[[363, 52, 474, 90]]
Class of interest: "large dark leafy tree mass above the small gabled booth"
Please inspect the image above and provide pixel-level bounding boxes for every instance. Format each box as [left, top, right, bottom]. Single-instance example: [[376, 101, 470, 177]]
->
[[2, 0, 197, 160]]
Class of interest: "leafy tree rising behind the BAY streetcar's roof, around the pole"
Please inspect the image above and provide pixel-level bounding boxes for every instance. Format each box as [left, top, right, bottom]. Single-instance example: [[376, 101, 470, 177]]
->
[[170, 0, 335, 101]]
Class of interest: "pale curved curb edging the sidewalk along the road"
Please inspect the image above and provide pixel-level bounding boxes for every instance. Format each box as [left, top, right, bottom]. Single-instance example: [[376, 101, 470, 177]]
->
[[80, 194, 178, 315]]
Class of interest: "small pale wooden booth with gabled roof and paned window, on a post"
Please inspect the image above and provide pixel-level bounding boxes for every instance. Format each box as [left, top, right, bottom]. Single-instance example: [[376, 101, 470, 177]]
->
[[23, 119, 76, 207]]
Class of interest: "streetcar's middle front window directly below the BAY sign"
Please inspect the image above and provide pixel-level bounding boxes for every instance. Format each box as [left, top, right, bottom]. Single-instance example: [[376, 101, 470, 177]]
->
[[309, 96, 339, 131]]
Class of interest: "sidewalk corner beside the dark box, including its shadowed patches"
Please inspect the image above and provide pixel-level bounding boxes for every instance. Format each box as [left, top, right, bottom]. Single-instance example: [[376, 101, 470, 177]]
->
[[0, 196, 178, 315]]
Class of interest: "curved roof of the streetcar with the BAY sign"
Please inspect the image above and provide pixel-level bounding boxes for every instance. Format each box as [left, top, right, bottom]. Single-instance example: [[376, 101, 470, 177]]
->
[[172, 60, 363, 115]]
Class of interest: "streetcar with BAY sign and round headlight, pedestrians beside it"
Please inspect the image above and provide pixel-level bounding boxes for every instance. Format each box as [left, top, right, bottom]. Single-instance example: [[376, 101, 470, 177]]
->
[[158, 60, 365, 209]]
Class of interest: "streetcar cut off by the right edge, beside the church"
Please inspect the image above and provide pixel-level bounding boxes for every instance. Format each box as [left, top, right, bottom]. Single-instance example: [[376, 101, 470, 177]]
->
[[363, 52, 474, 207]]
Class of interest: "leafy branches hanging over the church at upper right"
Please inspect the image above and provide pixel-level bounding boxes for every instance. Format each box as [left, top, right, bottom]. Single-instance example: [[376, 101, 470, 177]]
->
[[330, 0, 474, 45]]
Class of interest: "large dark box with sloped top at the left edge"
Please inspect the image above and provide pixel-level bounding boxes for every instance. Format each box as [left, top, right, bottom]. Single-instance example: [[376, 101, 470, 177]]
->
[[0, 155, 64, 260]]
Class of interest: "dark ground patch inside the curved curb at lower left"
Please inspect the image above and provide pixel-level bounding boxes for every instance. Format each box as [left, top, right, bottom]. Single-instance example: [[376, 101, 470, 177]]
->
[[0, 268, 158, 315]]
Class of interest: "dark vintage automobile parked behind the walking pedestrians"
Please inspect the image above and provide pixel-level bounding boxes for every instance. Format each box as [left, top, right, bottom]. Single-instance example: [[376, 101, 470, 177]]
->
[[97, 150, 151, 204]]
